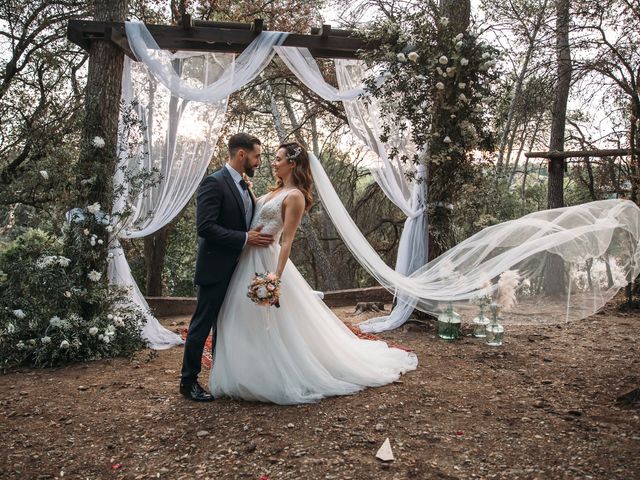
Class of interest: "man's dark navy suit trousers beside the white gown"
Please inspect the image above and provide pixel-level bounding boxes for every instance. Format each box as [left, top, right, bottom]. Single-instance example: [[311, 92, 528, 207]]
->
[[181, 279, 231, 385]]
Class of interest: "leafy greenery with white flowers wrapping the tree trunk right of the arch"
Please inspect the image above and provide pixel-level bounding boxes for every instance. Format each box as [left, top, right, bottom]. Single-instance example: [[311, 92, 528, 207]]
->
[[363, 7, 496, 173]]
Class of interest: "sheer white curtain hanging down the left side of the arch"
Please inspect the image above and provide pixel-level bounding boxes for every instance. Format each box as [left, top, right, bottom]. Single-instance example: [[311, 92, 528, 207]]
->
[[108, 31, 234, 349]]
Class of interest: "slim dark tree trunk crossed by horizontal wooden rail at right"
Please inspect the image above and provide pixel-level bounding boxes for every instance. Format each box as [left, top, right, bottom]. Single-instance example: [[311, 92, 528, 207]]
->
[[544, 0, 571, 296]]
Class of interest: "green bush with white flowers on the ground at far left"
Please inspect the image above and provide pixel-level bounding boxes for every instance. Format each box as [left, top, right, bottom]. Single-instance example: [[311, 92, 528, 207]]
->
[[0, 227, 144, 371]]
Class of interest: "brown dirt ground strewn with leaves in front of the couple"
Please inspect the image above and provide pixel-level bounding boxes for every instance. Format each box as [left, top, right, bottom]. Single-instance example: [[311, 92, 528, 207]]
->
[[0, 307, 640, 480]]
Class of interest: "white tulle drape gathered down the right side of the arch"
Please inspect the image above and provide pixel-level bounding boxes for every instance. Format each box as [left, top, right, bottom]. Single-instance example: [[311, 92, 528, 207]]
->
[[274, 46, 428, 332]]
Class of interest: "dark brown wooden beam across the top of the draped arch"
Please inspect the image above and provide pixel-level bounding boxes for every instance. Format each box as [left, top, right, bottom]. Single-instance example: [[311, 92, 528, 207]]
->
[[67, 15, 374, 60]]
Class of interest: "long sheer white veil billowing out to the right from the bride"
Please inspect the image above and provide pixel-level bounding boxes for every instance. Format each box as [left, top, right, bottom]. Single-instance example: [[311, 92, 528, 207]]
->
[[310, 154, 640, 323]]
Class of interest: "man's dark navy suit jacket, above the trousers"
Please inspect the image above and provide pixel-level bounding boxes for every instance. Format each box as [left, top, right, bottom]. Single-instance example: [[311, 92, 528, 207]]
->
[[194, 167, 255, 288]]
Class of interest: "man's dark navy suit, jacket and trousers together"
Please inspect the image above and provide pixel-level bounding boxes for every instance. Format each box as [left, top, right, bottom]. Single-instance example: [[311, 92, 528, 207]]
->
[[182, 167, 253, 385]]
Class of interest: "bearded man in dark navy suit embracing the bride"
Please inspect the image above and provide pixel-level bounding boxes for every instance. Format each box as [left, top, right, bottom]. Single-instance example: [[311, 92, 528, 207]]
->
[[180, 133, 273, 402]]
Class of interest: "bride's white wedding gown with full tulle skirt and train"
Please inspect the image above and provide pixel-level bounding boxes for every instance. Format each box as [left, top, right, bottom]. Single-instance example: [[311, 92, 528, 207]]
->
[[209, 190, 418, 405]]
